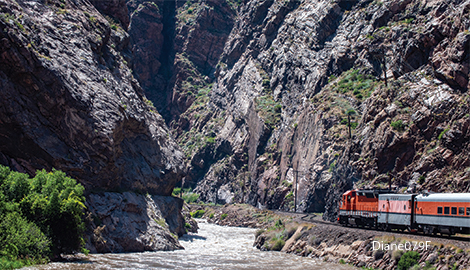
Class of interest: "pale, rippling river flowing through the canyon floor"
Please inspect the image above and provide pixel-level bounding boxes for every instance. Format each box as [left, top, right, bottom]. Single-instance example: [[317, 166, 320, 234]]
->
[[25, 220, 354, 270]]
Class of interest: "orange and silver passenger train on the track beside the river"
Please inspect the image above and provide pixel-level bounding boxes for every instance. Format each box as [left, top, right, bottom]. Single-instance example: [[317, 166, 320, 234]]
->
[[338, 190, 470, 236]]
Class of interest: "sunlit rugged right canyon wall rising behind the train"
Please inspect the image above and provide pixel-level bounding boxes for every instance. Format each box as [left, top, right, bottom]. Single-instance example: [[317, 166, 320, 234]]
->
[[140, 0, 470, 218]]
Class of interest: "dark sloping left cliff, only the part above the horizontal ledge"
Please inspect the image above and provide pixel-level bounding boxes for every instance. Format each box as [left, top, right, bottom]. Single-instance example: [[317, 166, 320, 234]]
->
[[0, 1, 183, 195]]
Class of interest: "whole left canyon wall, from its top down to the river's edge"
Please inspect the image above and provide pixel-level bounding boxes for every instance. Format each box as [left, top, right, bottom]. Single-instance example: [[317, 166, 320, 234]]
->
[[0, 0, 184, 251]]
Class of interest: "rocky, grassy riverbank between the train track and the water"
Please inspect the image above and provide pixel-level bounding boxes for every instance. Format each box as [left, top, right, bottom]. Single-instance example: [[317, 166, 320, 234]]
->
[[190, 204, 470, 270]]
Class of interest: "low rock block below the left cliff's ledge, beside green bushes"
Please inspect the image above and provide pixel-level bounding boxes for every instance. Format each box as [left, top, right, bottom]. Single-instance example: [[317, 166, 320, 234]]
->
[[87, 192, 185, 253]]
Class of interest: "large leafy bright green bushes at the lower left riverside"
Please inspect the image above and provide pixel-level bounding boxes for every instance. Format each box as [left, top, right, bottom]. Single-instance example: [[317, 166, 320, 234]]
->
[[0, 165, 85, 264]]
